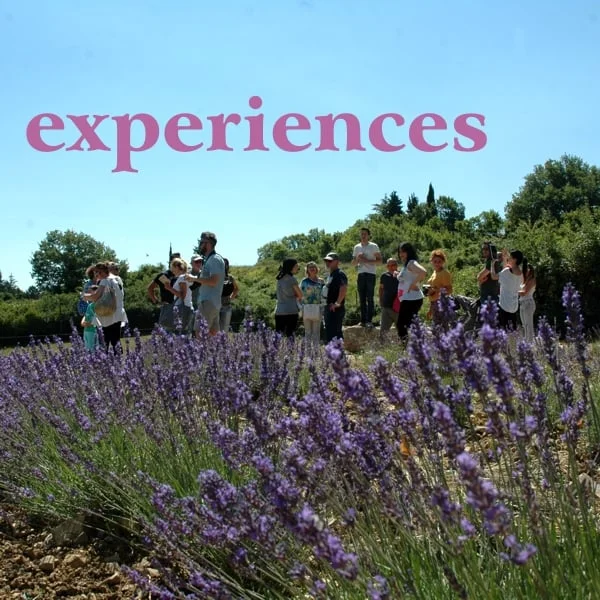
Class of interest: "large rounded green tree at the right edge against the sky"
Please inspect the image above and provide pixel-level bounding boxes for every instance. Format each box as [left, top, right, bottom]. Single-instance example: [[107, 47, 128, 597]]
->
[[505, 154, 600, 230]]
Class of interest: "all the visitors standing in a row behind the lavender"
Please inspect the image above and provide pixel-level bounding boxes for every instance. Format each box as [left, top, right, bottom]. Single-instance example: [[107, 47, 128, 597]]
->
[[80, 227, 536, 352]]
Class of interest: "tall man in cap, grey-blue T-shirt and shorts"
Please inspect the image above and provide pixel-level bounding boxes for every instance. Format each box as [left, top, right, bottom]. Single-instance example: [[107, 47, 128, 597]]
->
[[186, 231, 225, 337]]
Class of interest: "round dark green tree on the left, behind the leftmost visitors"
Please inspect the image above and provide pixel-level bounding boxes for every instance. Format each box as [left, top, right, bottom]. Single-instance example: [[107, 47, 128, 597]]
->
[[30, 229, 118, 294]]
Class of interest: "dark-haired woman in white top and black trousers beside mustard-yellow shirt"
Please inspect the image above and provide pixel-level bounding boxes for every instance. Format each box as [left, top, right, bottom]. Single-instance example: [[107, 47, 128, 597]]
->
[[395, 242, 427, 338]]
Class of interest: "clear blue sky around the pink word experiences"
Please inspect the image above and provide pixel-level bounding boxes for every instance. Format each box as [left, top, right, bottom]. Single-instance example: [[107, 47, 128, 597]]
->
[[0, 0, 600, 288]]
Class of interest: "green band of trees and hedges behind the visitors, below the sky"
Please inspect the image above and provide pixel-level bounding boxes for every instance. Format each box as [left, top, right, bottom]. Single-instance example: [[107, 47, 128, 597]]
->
[[0, 155, 600, 345]]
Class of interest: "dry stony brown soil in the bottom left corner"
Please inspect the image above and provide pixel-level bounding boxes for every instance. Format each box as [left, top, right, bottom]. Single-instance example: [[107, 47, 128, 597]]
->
[[0, 505, 158, 600]]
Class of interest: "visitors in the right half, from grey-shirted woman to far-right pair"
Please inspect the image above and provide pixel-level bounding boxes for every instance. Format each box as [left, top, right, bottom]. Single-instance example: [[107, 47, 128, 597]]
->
[[275, 227, 536, 344]]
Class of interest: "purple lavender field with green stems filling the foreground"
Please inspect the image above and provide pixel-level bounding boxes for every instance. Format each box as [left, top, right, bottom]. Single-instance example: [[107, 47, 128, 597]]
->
[[0, 286, 600, 600]]
